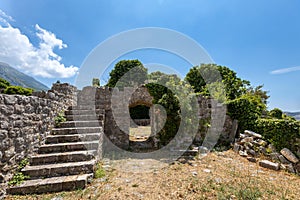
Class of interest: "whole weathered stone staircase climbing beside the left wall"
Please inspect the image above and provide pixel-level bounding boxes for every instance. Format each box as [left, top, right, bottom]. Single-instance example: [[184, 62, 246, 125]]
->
[[7, 104, 104, 194]]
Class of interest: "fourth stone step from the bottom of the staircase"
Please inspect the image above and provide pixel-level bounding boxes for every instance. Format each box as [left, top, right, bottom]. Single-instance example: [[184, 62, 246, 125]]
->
[[39, 141, 99, 154]]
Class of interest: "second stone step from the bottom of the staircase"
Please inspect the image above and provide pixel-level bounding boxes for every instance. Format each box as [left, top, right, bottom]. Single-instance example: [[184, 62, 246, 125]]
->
[[21, 160, 96, 179]]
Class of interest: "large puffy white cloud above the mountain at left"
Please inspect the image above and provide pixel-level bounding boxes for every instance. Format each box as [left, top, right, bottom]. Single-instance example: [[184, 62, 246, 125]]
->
[[0, 10, 78, 78]]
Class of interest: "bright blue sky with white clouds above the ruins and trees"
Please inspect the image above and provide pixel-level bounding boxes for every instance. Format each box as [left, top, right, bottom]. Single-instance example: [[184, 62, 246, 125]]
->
[[0, 0, 300, 111]]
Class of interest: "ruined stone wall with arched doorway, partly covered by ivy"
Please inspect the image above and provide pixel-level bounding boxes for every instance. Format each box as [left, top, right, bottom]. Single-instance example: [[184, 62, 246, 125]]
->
[[77, 86, 236, 150]]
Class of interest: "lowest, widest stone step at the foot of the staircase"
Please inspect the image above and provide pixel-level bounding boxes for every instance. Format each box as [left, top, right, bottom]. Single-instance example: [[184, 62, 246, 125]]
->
[[7, 174, 93, 195]]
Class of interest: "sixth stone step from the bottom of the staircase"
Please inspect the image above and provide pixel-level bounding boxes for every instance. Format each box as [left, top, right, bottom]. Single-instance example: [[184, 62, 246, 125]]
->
[[52, 127, 103, 135]]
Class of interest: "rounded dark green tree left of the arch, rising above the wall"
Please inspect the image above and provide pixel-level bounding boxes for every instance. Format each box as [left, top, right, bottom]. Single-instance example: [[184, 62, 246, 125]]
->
[[107, 60, 148, 87]]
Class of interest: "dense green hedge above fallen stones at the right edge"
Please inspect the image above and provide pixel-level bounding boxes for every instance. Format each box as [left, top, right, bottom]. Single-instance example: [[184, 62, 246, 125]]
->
[[255, 119, 300, 152]]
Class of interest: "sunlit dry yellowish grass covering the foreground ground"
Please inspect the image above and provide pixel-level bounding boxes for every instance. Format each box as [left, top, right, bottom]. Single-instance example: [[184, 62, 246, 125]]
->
[[7, 150, 300, 200]]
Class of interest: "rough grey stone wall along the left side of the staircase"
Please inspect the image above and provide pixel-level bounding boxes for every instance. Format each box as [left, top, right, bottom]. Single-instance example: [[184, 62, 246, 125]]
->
[[0, 84, 77, 196]]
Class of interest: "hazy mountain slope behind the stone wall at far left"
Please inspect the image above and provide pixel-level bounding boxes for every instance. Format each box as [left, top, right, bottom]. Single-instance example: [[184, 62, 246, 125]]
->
[[0, 62, 49, 91]]
